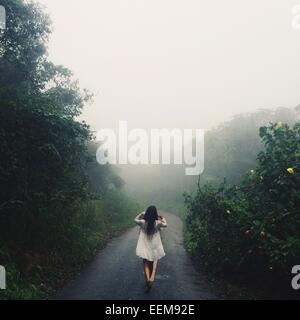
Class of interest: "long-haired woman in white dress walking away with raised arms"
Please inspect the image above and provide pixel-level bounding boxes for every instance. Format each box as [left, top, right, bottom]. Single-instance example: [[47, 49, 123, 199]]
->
[[134, 206, 167, 290]]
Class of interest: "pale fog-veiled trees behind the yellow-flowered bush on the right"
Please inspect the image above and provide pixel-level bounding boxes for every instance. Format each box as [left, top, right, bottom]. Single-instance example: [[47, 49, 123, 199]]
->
[[202, 108, 298, 184]]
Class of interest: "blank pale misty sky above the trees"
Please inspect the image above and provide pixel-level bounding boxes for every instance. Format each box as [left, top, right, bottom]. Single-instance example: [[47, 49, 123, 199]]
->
[[39, 0, 300, 129]]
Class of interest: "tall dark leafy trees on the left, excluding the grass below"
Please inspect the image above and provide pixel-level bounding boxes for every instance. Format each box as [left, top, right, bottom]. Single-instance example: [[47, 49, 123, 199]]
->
[[0, 0, 91, 247]]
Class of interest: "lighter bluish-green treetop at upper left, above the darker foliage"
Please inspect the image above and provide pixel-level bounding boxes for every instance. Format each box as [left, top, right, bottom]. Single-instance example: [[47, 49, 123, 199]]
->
[[0, 0, 91, 118]]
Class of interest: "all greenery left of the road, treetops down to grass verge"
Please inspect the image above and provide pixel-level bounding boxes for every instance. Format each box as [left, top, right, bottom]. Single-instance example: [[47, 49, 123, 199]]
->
[[0, 0, 138, 299]]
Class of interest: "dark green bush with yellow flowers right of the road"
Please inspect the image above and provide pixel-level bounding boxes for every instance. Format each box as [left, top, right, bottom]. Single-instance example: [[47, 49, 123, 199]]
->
[[185, 114, 300, 297]]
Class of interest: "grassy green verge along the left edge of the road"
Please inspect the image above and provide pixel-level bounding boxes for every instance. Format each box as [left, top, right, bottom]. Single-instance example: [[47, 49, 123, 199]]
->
[[0, 192, 141, 300]]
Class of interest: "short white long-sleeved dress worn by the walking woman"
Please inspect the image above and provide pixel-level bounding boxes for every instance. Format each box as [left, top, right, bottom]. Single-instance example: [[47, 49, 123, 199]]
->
[[134, 213, 167, 261]]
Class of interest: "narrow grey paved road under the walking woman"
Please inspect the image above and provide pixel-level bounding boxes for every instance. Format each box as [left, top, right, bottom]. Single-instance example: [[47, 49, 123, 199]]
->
[[57, 213, 221, 300]]
